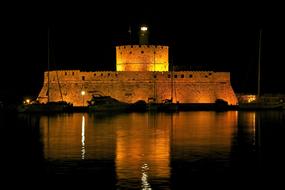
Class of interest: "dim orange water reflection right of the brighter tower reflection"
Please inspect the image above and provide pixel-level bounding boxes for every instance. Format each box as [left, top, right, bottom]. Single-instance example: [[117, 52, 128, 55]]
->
[[171, 111, 237, 160]]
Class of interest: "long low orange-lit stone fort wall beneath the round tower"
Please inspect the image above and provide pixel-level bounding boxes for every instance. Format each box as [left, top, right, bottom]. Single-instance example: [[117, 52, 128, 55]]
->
[[38, 70, 237, 106]]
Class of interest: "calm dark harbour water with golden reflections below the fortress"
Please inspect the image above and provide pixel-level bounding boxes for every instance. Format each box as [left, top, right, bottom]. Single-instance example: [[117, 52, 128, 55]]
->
[[0, 111, 285, 189]]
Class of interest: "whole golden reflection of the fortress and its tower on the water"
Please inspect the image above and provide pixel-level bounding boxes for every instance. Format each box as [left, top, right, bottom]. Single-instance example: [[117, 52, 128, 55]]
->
[[40, 111, 242, 186]]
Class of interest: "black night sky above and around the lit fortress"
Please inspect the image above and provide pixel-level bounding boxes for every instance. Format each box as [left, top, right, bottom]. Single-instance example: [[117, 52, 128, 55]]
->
[[0, 2, 285, 103]]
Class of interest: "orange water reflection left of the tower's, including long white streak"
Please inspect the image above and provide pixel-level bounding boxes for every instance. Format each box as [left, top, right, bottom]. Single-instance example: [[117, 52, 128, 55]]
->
[[40, 113, 116, 160]]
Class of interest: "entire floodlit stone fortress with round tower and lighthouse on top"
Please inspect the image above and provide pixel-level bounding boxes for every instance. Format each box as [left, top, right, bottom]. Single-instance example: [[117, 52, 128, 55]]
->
[[37, 27, 238, 106]]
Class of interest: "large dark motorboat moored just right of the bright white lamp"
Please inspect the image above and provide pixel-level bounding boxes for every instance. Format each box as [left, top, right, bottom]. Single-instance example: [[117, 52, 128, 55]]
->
[[87, 95, 130, 112]]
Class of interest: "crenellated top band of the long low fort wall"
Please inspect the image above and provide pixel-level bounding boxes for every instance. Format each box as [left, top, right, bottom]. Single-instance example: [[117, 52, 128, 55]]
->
[[44, 70, 230, 83]]
